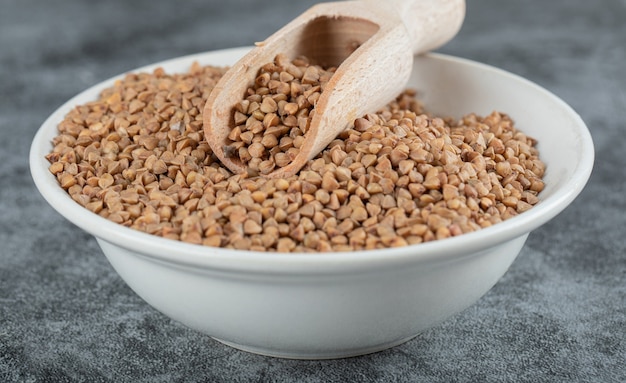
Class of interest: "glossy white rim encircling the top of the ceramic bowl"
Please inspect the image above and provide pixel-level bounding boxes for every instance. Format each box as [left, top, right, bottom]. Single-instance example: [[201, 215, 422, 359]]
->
[[29, 47, 594, 274]]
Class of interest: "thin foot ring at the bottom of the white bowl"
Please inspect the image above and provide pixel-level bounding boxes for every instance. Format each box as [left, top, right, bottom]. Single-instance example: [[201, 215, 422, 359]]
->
[[212, 334, 419, 360]]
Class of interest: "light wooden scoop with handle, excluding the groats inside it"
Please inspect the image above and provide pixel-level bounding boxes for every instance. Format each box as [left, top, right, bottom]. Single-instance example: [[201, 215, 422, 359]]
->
[[203, 0, 465, 178]]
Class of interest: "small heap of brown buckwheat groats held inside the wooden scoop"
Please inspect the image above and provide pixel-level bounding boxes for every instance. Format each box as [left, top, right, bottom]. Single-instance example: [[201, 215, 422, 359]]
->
[[225, 55, 336, 175]]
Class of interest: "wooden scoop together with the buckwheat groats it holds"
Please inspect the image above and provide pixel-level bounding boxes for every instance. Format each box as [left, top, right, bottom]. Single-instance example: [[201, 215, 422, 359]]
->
[[204, 0, 465, 178]]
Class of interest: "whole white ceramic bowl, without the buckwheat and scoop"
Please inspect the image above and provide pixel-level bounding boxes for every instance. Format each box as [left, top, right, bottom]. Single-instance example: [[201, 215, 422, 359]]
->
[[30, 48, 594, 359]]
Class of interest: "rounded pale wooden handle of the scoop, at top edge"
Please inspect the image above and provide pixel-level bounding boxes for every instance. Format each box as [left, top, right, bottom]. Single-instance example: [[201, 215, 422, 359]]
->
[[363, 0, 465, 54]]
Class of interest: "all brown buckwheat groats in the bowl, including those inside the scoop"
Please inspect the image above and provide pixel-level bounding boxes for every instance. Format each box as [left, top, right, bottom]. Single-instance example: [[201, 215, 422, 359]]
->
[[46, 56, 545, 252]]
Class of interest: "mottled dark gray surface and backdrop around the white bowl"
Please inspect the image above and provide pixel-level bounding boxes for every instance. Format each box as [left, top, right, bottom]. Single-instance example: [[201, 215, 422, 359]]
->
[[0, 0, 626, 382]]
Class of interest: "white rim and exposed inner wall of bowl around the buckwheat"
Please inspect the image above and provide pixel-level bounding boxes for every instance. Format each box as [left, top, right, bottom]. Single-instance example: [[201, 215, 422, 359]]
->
[[30, 47, 594, 270]]
